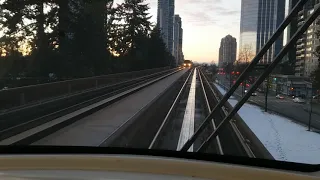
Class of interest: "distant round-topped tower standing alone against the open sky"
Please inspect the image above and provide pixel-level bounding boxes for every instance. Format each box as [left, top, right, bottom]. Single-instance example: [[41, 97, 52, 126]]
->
[[219, 35, 237, 67]]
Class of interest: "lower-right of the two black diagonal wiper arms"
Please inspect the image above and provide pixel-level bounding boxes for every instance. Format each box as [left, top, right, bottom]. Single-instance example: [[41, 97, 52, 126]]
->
[[197, 7, 320, 152]]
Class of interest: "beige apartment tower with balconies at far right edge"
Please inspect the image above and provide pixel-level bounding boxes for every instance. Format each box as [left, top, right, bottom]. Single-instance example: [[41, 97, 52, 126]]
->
[[295, 0, 320, 77]]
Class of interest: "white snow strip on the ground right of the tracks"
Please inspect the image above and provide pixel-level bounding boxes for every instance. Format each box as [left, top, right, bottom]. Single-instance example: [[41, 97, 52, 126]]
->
[[215, 84, 320, 164]]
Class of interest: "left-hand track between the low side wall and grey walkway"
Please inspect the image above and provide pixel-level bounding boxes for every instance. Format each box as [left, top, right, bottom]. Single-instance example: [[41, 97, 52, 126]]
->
[[0, 70, 180, 145]]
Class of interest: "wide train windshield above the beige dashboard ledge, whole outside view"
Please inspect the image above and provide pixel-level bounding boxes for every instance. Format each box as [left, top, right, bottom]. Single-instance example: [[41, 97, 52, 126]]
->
[[0, 0, 320, 172]]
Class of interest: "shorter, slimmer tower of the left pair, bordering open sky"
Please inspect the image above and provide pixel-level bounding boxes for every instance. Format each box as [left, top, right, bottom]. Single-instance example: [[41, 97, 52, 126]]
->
[[173, 15, 182, 65]]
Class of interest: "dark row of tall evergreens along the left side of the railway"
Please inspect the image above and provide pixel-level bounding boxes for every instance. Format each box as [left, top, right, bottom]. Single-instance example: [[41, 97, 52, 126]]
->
[[0, 0, 174, 87]]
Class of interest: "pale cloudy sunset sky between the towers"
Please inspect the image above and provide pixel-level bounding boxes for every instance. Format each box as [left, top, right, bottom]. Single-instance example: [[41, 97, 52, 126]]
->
[[114, 0, 241, 63]]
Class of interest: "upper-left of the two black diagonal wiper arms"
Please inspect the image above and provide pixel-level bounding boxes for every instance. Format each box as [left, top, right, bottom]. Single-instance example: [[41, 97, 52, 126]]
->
[[181, 0, 317, 151]]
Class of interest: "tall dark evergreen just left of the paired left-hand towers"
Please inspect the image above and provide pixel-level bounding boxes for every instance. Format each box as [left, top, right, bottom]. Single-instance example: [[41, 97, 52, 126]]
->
[[109, 0, 151, 70]]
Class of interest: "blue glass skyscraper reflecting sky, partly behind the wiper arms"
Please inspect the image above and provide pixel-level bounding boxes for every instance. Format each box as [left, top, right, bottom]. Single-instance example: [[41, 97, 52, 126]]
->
[[239, 0, 285, 63]]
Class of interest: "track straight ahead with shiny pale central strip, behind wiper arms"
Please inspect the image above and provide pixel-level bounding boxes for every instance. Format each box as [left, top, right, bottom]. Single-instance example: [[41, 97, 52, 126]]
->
[[148, 68, 255, 157]]
